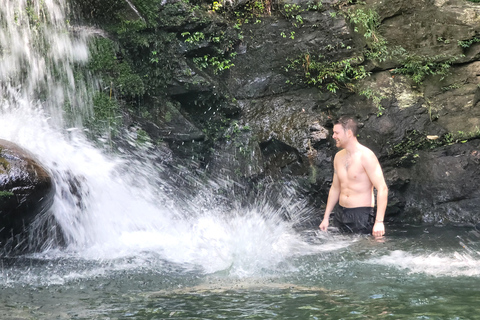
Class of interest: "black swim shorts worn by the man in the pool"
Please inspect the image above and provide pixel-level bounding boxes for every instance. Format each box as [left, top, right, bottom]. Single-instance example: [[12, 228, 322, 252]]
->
[[334, 206, 375, 234]]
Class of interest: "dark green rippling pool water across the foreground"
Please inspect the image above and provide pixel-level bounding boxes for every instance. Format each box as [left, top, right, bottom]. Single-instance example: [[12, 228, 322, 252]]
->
[[0, 227, 480, 319]]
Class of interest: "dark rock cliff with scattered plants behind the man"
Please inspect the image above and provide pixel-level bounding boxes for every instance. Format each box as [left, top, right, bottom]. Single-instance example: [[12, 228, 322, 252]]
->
[[79, 0, 480, 224]]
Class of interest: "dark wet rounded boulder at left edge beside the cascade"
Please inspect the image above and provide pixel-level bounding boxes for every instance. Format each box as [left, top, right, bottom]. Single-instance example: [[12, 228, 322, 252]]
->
[[0, 139, 55, 245]]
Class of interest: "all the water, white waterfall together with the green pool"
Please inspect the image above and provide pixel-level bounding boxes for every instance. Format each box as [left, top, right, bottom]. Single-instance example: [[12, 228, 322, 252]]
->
[[0, 0, 480, 319]]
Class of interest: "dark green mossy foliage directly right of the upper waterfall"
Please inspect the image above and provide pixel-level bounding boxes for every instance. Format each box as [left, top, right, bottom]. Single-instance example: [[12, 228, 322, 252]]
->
[[79, 0, 208, 97]]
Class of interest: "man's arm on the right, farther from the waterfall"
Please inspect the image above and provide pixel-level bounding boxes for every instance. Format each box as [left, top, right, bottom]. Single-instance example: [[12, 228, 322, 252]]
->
[[364, 151, 388, 237]]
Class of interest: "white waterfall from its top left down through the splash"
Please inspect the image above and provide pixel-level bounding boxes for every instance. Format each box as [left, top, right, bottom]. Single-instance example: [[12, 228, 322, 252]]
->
[[0, 0, 326, 273]]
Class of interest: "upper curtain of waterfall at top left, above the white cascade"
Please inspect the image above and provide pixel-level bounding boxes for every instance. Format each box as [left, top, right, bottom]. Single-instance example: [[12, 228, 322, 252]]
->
[[0, 0, 91, 127]]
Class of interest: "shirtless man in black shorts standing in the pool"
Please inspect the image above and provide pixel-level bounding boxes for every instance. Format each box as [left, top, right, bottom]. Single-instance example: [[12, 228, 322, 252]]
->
[[320, 116, 388, 237]]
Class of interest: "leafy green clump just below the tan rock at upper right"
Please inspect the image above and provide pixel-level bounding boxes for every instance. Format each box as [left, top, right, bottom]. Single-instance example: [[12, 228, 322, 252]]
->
[[394, 55, 460, 84]]
